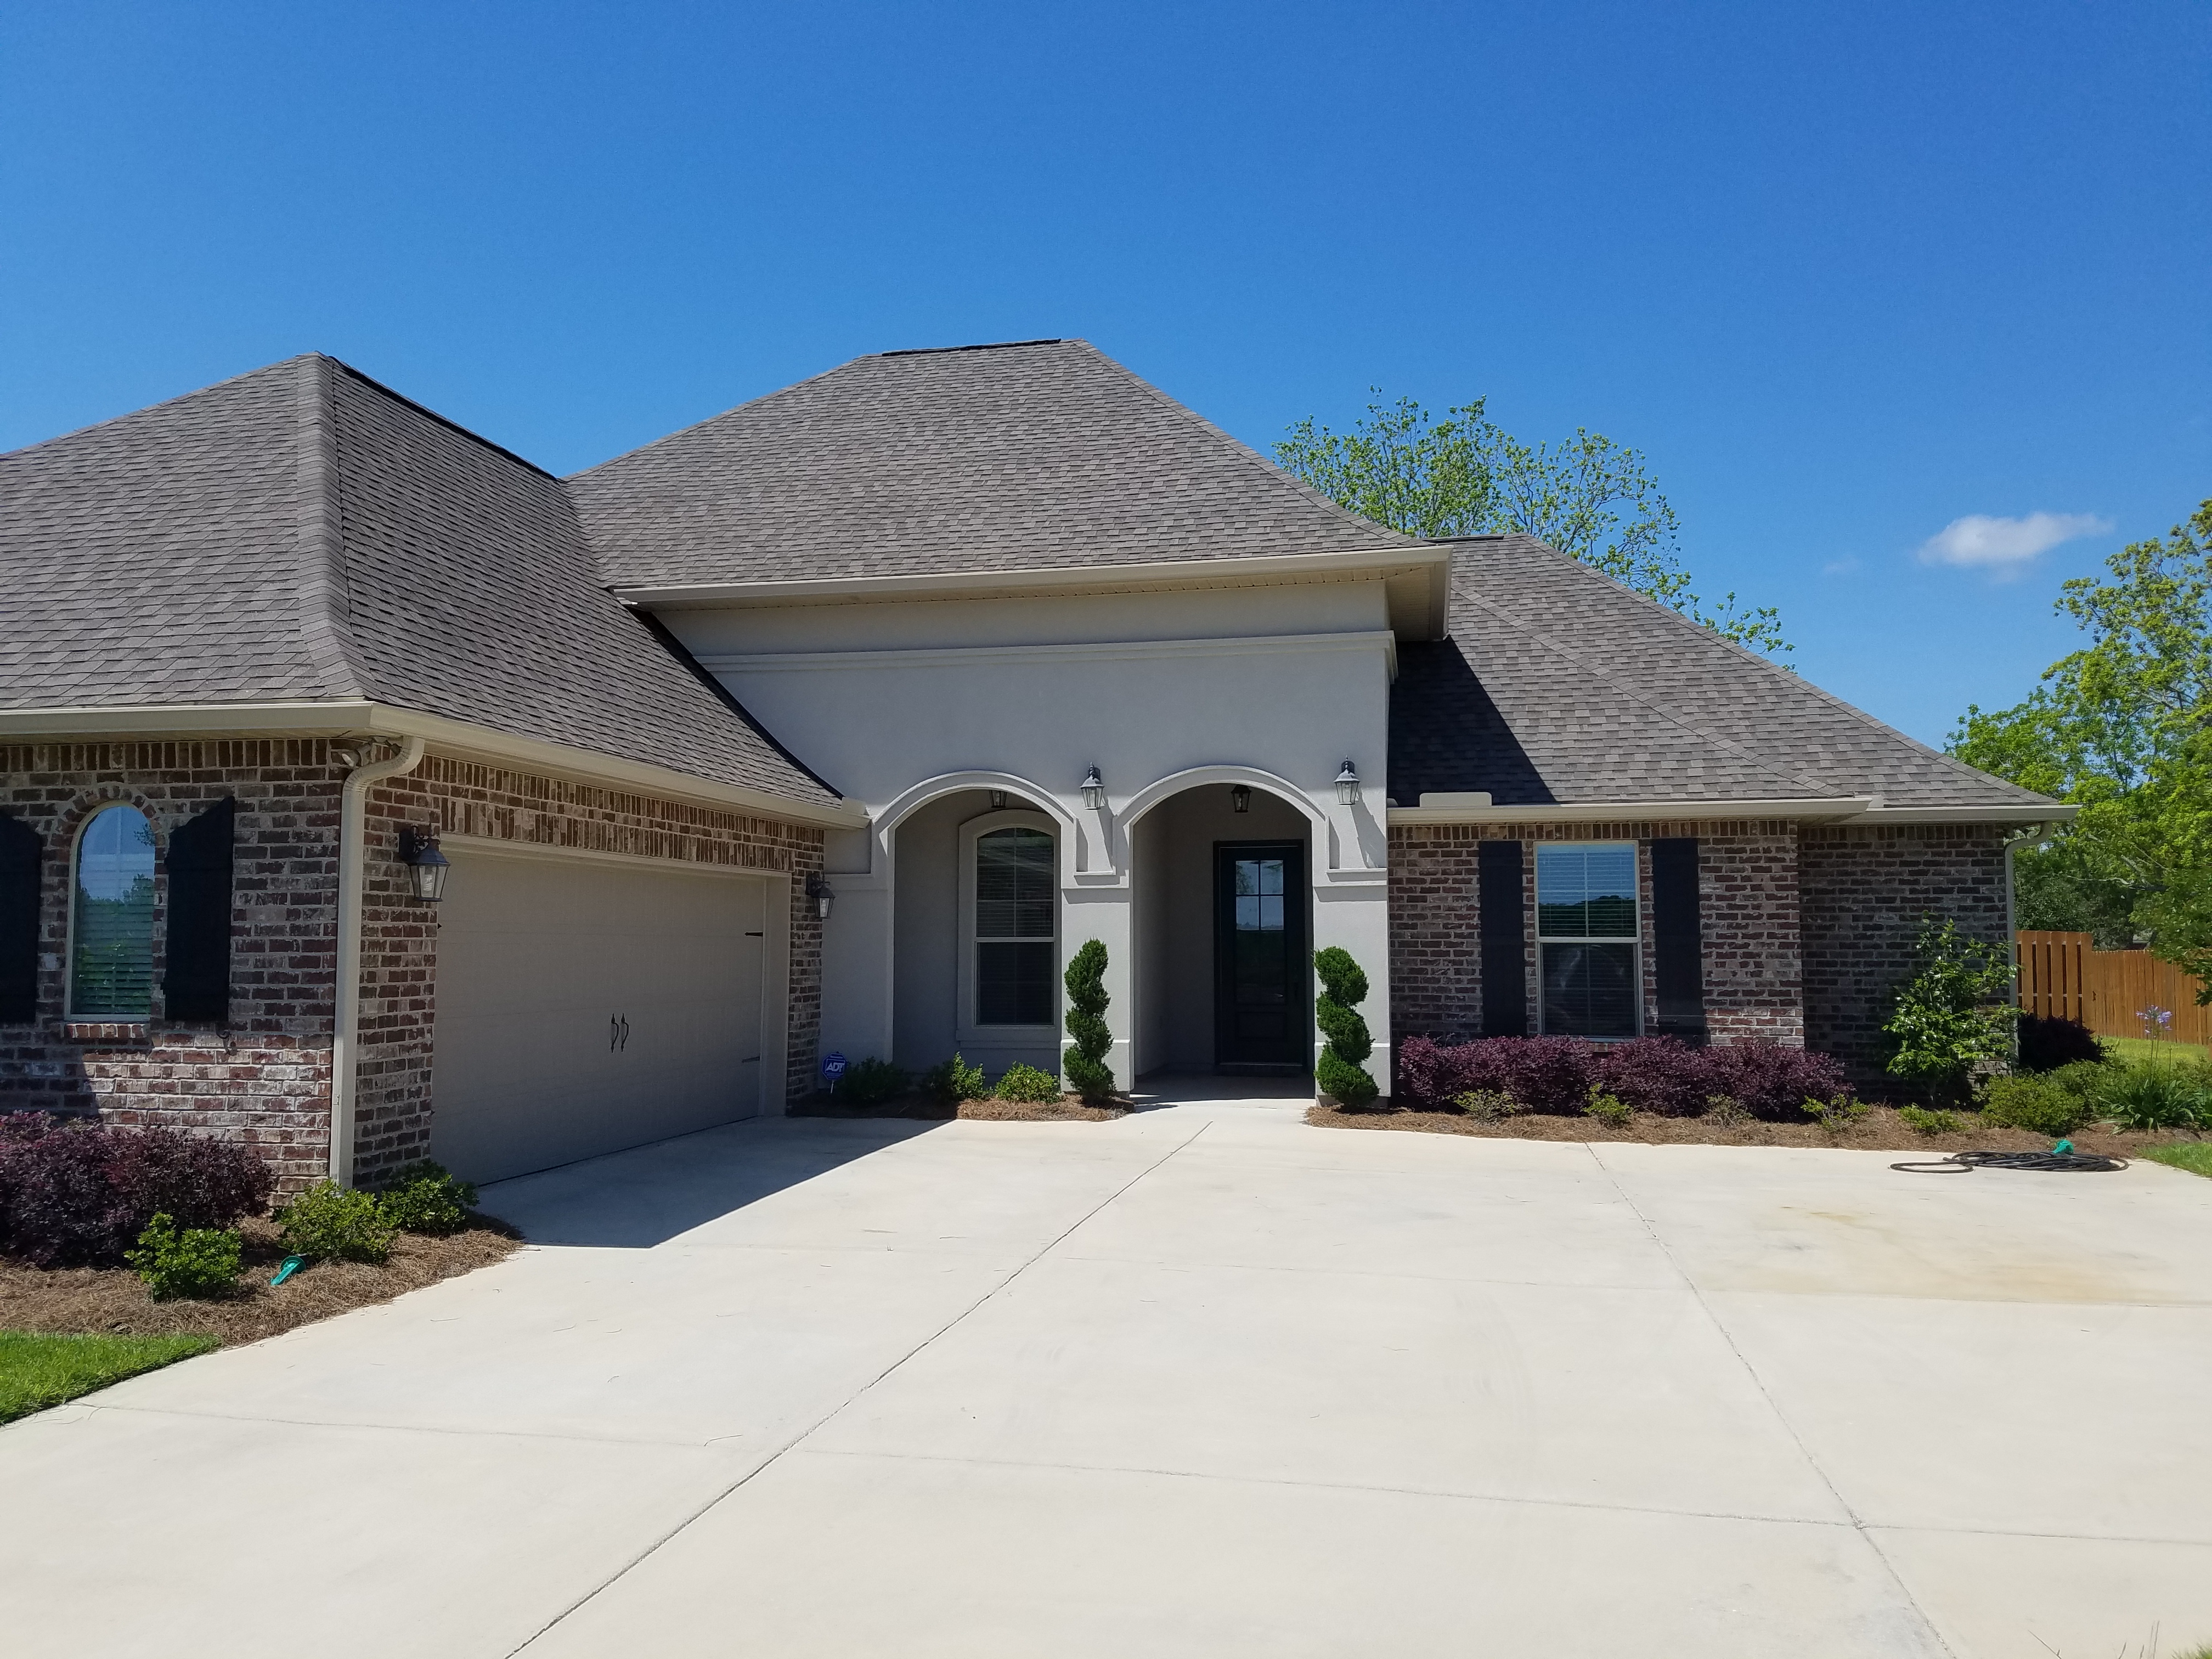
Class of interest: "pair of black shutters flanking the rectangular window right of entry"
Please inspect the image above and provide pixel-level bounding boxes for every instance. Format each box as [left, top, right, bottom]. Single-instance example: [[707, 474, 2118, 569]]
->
[[1475, 836, 1706, 1042]]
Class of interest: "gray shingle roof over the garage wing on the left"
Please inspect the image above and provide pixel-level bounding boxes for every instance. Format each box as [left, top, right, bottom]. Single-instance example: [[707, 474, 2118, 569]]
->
[[0, 356, 836, 803]]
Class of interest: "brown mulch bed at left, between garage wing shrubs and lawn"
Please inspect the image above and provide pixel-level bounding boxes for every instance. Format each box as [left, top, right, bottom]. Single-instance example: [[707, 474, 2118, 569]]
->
[[0, 1217, 522, 1345]]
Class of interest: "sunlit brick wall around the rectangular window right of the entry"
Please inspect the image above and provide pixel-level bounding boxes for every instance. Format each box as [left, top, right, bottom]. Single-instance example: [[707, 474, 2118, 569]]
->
[[1389, 821, 1805, 1044]]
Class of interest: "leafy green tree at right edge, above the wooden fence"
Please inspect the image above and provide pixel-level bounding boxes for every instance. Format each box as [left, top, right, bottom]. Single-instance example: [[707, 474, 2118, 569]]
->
[[1949, 500, 2212, 1000]]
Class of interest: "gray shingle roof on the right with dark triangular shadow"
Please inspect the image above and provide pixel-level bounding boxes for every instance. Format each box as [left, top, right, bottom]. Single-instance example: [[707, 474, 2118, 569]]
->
[[1389, 535, 2044, 808]]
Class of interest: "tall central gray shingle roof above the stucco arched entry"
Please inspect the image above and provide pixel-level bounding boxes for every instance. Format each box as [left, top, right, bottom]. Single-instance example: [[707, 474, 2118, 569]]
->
[[568, 341, 1413, 589]]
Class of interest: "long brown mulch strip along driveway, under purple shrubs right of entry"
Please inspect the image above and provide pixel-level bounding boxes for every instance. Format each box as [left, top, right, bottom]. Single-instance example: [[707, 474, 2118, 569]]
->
[[1305, 1106, 2183, 1157]]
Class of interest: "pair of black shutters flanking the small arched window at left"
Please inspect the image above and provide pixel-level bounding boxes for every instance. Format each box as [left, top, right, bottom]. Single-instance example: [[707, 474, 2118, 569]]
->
[[0, 799, 239, 1024]]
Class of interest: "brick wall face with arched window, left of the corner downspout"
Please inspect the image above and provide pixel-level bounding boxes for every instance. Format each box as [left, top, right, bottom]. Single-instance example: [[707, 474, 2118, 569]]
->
[[0, 739, 341, 1186]]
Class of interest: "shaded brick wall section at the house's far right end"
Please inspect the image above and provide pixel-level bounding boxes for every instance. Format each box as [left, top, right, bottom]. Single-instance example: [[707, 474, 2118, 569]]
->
[[1798, 823, 2008, 1093]]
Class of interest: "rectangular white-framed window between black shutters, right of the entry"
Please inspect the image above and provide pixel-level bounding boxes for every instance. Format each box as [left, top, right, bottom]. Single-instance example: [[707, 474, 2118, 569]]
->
[[1535, 843, 1644, 1037]]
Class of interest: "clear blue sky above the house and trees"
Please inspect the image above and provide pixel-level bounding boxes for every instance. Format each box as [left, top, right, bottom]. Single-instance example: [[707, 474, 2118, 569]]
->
[[0, 0, 2212, 741]]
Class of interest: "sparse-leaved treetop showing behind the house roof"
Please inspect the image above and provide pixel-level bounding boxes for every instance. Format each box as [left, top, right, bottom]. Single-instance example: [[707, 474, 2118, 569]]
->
[[1274, 392, 1790, 652]]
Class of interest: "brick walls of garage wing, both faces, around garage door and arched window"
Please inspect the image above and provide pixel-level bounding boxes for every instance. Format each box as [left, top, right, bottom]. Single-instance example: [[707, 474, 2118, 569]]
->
[[0, 737, 823, 1190]]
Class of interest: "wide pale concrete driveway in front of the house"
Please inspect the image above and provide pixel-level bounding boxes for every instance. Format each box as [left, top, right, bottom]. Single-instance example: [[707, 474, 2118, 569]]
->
[[0, 1102, 2212, 1659]]
